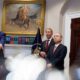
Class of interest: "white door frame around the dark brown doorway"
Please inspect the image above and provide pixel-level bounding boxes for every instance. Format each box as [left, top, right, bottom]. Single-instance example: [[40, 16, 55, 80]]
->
[[63, 12, 80, 67]]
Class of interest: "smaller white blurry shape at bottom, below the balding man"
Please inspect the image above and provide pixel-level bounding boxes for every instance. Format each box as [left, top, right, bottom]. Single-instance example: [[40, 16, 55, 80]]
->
[[45, 69, 67, 80]]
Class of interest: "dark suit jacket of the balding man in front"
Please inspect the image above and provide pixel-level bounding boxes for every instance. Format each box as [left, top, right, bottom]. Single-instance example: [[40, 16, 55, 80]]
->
[[47, 44, 67, 70]]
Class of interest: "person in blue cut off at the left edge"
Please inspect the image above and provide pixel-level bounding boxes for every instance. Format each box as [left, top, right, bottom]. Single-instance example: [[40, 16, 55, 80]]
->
[[0, 32, 6, 59]]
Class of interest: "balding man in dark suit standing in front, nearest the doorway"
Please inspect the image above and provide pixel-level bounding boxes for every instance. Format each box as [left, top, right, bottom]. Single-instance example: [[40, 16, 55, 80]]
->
[[47, 33, 67, 70]]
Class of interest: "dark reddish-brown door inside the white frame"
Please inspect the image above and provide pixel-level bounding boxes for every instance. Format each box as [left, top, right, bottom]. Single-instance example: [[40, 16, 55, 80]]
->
[[70, 18, 80, 65]]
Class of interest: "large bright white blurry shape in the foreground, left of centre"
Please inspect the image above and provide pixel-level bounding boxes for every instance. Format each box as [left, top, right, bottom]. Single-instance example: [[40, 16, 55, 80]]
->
[[6, 54, 46, 80]]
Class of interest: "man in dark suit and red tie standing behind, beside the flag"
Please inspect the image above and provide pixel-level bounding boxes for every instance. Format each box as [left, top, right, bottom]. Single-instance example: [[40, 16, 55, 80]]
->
[[40, 28, 54, 57]]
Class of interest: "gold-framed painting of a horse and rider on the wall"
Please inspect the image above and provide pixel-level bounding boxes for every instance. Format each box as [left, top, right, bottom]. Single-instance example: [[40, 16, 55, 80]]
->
[[2, 0, 46, 36]]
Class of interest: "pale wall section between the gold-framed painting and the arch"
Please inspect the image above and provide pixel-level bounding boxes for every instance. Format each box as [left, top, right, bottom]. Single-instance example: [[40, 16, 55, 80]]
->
[[45, 0, 65, 32]]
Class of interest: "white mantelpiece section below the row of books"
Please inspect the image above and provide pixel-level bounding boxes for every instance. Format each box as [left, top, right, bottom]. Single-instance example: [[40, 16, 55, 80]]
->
[[4, 44, 31, 57]]
